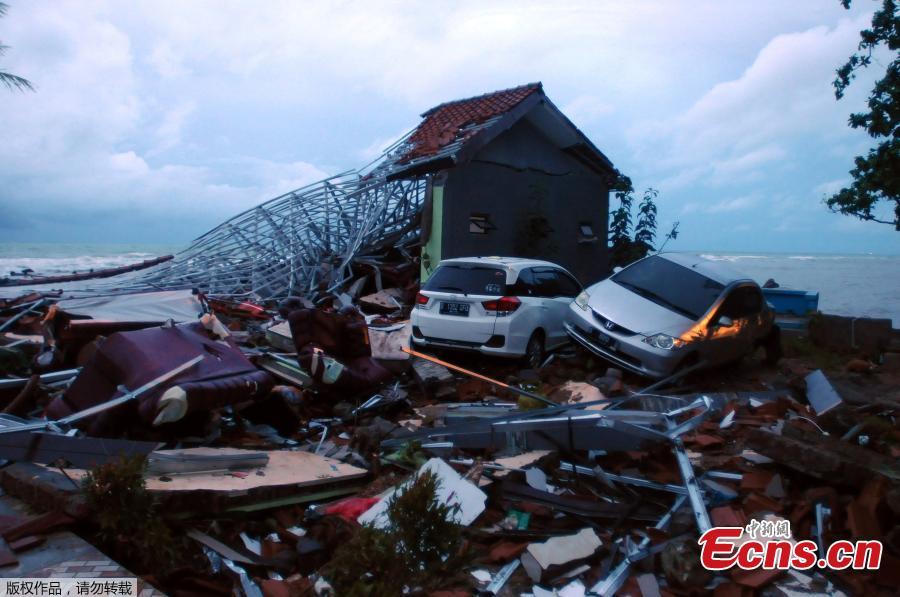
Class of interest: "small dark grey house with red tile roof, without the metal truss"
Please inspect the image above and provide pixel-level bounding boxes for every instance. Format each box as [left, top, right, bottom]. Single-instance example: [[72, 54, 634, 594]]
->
[[392, 83, 615, 282]]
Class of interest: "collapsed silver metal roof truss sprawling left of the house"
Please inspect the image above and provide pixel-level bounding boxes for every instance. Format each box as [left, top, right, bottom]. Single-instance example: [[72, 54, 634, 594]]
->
[[117, 135, 427, 299]]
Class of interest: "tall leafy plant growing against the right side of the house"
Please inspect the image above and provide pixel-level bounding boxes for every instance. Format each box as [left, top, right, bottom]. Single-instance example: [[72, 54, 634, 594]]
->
[[609, 173, 659, 267]]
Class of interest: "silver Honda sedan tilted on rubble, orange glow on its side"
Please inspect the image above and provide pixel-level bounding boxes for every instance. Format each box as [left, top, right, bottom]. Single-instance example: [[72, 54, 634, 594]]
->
[[565, 253, 780, 379]]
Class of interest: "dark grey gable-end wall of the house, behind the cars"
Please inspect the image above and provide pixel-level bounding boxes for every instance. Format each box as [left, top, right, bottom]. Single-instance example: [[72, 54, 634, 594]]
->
[[441, 119, 609, 284]]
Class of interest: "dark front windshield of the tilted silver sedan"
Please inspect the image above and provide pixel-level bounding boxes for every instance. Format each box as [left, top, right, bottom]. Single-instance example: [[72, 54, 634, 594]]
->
[[611, 256, 725, 321]]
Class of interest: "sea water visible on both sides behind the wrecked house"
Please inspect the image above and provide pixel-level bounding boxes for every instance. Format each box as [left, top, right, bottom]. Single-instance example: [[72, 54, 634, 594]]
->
[[0, 243, 900, 327]]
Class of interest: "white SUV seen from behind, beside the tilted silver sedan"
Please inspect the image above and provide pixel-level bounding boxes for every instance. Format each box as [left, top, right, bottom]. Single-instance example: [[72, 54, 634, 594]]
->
[[412, 257, 582, 367]]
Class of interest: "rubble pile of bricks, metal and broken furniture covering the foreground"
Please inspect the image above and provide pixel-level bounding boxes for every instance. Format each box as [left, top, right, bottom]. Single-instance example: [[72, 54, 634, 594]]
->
[[0, 260, 900, 597]]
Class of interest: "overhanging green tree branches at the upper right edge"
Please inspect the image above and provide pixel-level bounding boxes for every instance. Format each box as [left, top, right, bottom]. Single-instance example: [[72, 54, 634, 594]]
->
[[825, 0, 900, 230]]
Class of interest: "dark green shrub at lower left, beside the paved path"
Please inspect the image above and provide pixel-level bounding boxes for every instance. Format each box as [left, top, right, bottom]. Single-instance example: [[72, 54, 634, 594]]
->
[[82, 456, 179, 574]]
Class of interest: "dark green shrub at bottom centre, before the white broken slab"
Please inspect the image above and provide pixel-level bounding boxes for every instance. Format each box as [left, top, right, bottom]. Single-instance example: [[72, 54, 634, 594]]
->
[[322, 472, 468, 596]]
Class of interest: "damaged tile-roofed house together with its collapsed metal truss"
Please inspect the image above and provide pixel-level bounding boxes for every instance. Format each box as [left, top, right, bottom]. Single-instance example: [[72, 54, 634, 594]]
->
[[77, 83, 616, 300]]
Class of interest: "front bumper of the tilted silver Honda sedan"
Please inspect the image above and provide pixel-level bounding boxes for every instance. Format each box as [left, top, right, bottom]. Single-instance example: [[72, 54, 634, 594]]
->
[[563, 309, 683, 379]]
